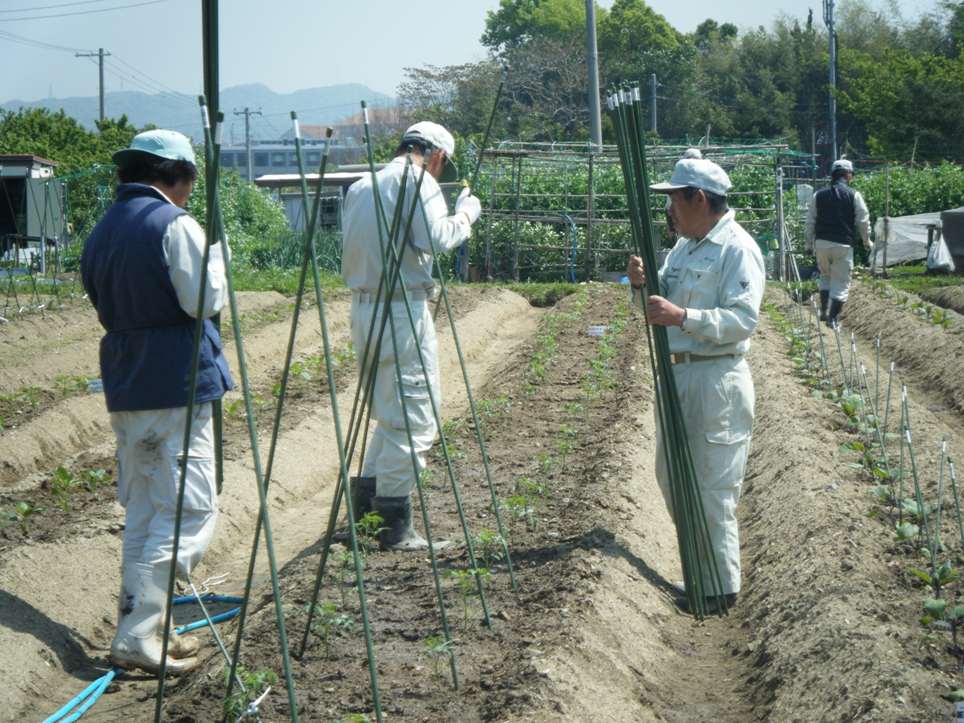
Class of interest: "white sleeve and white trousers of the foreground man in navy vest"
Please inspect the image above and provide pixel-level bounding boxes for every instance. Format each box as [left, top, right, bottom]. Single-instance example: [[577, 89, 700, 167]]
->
[[110, 206, 228, 575]]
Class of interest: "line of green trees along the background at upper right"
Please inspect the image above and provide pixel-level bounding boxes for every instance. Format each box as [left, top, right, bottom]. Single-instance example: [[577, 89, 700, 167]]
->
[[398, 0, 964, 161]]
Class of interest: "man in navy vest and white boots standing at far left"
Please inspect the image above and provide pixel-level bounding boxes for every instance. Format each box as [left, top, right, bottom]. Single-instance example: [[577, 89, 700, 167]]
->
[[80, 130, 231, 674]]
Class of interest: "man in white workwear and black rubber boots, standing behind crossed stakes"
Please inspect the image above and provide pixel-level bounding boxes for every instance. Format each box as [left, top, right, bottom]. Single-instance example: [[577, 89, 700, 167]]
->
[[341, 121, 482, 551]]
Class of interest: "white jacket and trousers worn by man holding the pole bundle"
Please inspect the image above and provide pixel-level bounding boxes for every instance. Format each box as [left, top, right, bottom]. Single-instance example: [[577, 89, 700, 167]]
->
[[632, 210, 766, 594]]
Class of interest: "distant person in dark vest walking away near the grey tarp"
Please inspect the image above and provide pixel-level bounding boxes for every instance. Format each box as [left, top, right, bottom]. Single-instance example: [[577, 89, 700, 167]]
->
[[804, 159, 874, 327]]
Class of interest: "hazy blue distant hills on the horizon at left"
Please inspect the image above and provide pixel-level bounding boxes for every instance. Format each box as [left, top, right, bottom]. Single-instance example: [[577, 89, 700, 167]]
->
[[0, 83, 395, 142]]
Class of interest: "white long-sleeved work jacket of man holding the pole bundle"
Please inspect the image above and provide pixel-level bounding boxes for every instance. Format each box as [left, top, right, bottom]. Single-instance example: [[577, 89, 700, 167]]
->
[[632, 210, 766, 356]]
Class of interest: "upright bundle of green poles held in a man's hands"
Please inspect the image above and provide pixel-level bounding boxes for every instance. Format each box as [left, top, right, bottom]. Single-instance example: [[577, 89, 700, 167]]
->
[[608, 87, 728, 620]]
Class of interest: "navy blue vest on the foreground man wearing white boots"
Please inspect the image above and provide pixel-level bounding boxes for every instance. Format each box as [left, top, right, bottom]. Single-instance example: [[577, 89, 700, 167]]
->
[[80, 183, 232, 412]]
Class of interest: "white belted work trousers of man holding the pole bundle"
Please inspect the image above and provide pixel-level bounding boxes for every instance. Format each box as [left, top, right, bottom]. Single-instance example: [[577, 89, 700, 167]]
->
[[656, 356, 754, 595]]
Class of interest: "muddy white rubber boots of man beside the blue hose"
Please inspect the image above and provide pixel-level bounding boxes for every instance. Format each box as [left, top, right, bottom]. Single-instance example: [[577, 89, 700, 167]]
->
[[107, 562, 199, 675]]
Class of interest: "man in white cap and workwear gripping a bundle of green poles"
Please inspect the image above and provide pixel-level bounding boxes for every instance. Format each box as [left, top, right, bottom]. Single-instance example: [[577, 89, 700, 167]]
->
[[627, 158, 766, 614]]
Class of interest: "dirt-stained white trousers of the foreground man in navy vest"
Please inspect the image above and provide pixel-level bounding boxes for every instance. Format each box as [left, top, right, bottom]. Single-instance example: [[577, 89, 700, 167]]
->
[[110, 402, 218, 575]]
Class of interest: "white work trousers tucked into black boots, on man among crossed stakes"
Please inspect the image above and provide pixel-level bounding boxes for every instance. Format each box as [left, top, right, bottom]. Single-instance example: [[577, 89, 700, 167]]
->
[[350, 297, 441, 497]]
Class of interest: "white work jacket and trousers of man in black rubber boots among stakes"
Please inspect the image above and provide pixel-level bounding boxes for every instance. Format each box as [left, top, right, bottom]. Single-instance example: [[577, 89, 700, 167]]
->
[[341, 158, 471, 497]]
